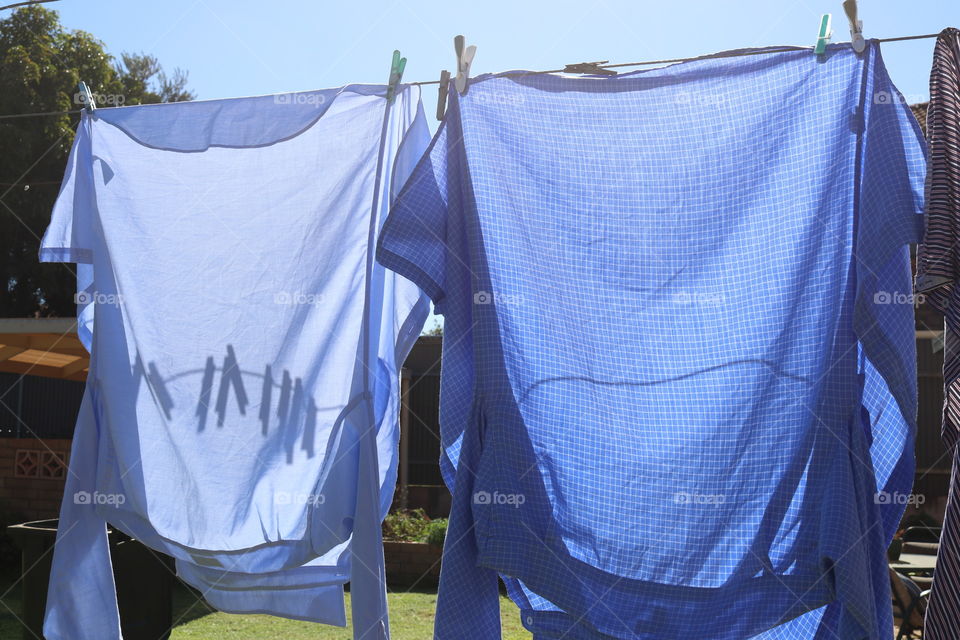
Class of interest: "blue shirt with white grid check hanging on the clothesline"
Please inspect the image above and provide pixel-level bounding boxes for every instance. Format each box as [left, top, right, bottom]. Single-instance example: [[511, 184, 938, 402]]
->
[[377, 41, 925, 640]]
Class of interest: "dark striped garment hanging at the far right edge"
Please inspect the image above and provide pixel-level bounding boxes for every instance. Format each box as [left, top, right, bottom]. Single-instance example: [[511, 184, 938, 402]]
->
[[916, 28, 960, 640]]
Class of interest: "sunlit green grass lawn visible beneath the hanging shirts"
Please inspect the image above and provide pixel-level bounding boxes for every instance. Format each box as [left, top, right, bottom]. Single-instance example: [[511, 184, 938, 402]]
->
[[0, 573, 531, 640]]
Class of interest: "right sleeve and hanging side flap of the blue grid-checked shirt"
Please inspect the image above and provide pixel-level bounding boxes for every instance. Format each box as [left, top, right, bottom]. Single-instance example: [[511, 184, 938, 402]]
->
[[852, 43, 926, 637]]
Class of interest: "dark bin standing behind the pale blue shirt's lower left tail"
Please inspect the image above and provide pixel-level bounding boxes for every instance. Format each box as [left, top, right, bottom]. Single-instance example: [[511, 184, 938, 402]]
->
[[7, 519, 174, 640]]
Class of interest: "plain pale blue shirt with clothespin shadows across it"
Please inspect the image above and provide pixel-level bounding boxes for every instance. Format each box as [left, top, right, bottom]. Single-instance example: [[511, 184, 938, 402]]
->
[[40, 85, 429, 640]]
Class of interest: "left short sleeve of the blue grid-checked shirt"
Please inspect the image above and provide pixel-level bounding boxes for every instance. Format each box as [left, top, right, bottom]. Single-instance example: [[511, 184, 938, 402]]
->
[[377, 123, 451, 313]]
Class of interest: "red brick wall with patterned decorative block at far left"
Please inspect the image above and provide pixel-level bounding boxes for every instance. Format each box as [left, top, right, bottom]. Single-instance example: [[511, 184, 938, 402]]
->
[[0, 438, 70, 520]]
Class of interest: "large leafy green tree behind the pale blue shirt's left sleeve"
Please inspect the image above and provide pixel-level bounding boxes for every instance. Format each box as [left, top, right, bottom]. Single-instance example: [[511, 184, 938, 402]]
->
[[0, 6, 194, 317]]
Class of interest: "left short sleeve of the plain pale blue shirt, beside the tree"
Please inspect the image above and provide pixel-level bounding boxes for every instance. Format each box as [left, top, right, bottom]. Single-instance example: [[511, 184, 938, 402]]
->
[[40, 113, 95, 264]]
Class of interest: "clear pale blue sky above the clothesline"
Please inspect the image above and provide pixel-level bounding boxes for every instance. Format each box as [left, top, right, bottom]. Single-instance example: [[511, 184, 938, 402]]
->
[[47, 0, 960, 327]]
